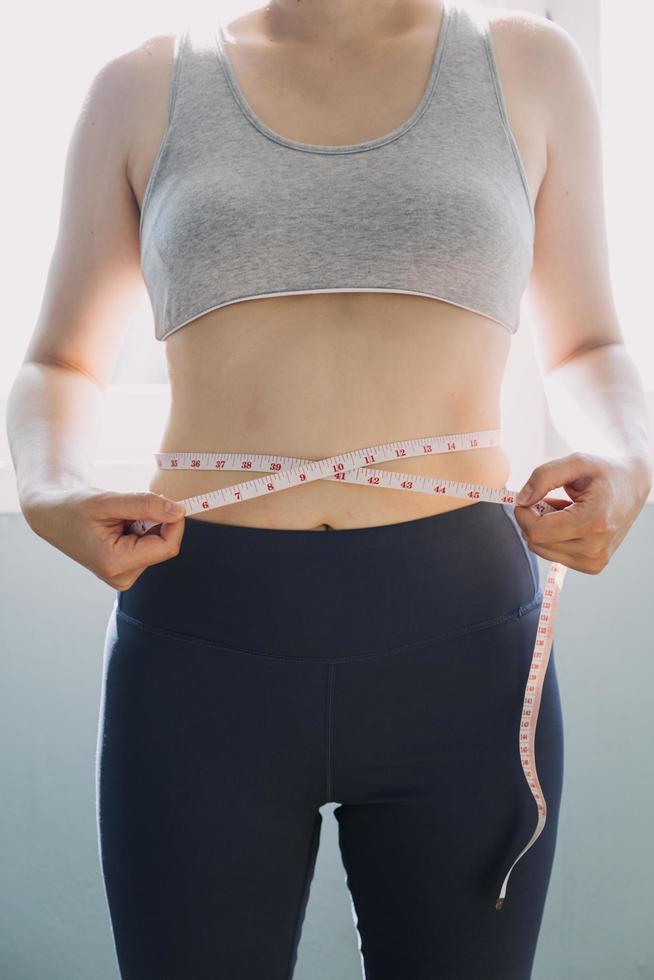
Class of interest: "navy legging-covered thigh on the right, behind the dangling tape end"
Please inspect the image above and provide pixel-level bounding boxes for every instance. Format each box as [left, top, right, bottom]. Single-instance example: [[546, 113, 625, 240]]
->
[[334, 607, 563, 980]]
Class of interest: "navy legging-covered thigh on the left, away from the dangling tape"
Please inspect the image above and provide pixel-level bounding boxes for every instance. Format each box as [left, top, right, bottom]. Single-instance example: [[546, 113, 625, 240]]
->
[[96, 612, 326, 980]]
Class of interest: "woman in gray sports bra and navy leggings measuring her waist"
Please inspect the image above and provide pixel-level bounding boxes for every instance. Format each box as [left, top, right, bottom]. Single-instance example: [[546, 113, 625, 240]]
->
[[9, 0, 652, 980]]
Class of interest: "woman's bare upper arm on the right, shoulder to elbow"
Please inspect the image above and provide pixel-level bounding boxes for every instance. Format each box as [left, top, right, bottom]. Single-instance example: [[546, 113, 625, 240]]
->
[[525, 16, 623, 371]]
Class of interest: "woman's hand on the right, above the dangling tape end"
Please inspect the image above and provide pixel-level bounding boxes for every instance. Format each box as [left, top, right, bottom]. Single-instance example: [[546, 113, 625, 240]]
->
[[514, 453, 652, 575]]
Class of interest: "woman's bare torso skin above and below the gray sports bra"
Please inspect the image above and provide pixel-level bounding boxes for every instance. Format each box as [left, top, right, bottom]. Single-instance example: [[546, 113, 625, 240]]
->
[[125, 3, 545, 530]]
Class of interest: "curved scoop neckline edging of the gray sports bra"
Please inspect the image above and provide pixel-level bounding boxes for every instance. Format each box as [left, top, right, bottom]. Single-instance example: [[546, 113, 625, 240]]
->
[[211, 0, 453, 154]]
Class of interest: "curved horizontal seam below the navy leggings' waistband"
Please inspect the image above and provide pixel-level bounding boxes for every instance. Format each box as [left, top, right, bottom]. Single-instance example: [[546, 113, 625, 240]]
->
[[116, 589, 543, 664]]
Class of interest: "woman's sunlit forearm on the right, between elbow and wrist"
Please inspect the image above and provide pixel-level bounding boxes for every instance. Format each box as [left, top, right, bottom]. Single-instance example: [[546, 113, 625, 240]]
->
[[545, 344, 653, 479]]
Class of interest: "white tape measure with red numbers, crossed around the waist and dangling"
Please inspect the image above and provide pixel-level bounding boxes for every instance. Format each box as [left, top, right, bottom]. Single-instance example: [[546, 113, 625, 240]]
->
[[128, 429, 567, 910]]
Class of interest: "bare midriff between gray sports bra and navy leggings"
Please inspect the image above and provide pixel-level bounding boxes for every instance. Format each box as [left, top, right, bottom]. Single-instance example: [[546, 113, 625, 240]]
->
[[150, 293, 511, 530]]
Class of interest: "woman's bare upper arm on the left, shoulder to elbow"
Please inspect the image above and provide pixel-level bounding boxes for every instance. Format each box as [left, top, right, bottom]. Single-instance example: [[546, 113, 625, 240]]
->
[[24, 42, 161, 387]]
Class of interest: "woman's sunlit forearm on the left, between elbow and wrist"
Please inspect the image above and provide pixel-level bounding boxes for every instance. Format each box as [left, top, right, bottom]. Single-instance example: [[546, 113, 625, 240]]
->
[[7, 361, 105, 516]]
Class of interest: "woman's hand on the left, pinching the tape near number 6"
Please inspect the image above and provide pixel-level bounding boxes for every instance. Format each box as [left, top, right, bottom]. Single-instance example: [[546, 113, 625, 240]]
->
[[21, 487, 185, 592]]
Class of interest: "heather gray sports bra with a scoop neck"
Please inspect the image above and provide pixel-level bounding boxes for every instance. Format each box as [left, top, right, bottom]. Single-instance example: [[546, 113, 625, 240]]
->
[[140, 0, 535, 340]]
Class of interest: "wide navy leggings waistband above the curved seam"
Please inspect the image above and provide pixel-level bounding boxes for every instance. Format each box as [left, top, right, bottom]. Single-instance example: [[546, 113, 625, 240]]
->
[[118, 501, 541, 660]]
